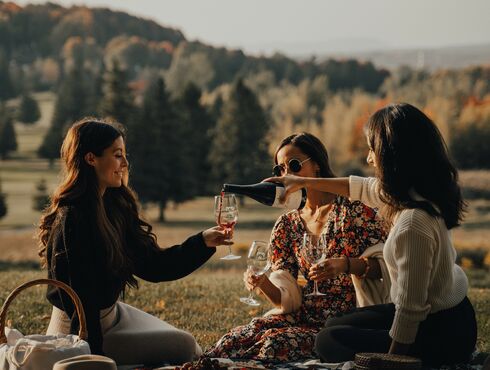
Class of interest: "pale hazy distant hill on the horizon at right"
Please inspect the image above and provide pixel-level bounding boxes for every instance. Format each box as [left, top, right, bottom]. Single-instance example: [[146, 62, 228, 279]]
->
[[324, 44, 490, 71]]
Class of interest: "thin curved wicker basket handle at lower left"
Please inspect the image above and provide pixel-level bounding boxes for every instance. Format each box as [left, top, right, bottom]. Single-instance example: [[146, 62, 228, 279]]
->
[[0, 279, 88, 344]]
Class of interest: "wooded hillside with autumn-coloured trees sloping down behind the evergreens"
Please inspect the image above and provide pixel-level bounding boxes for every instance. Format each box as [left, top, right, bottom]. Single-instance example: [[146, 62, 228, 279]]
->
[[0, 1, 389, 95]]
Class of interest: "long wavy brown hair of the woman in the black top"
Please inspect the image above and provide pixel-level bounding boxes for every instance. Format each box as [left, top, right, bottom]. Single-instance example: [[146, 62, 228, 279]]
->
[[39, 117, 156, 286]]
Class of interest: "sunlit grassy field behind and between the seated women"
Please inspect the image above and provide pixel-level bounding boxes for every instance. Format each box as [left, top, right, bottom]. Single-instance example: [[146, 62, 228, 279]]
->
[[0, 93, 490, 352]]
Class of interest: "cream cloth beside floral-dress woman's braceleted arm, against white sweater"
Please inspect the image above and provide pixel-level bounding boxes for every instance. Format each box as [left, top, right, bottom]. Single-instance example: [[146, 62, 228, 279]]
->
[[351, 243, 391, 307]]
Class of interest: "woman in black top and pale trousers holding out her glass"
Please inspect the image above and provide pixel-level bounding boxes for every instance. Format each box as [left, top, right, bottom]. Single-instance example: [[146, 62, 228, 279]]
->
[[39, 118, 230, 364]]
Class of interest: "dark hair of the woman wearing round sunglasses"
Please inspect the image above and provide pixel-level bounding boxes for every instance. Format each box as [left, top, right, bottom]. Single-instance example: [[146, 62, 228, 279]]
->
[[274, 132, 335, 177]]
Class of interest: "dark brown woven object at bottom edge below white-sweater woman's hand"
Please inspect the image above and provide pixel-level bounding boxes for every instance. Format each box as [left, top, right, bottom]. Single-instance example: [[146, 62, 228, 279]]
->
[[355, 353, 422, 370]]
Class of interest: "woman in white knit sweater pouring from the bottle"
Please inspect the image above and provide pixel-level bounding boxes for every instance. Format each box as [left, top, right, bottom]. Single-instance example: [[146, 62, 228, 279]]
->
[[268, 104, 477, 366]]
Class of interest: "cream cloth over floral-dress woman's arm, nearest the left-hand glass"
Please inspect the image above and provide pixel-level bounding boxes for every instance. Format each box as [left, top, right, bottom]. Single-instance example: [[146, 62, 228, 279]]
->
[[265, 270, 302, 316]]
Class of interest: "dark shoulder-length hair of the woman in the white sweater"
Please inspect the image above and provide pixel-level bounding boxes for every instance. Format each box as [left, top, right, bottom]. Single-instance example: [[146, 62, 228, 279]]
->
[[366, 103, 466, 229]]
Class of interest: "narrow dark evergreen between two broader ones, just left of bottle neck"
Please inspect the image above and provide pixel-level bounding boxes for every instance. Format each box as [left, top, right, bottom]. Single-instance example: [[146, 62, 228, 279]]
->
[[179, 83, 216, 195]]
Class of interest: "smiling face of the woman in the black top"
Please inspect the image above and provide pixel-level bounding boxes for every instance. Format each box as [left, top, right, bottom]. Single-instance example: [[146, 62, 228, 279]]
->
[[86, 136, 128, 193]]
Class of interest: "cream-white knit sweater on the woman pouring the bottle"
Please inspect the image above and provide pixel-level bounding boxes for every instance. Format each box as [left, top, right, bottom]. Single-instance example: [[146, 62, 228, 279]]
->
[[349, 176, 468, 344]]
